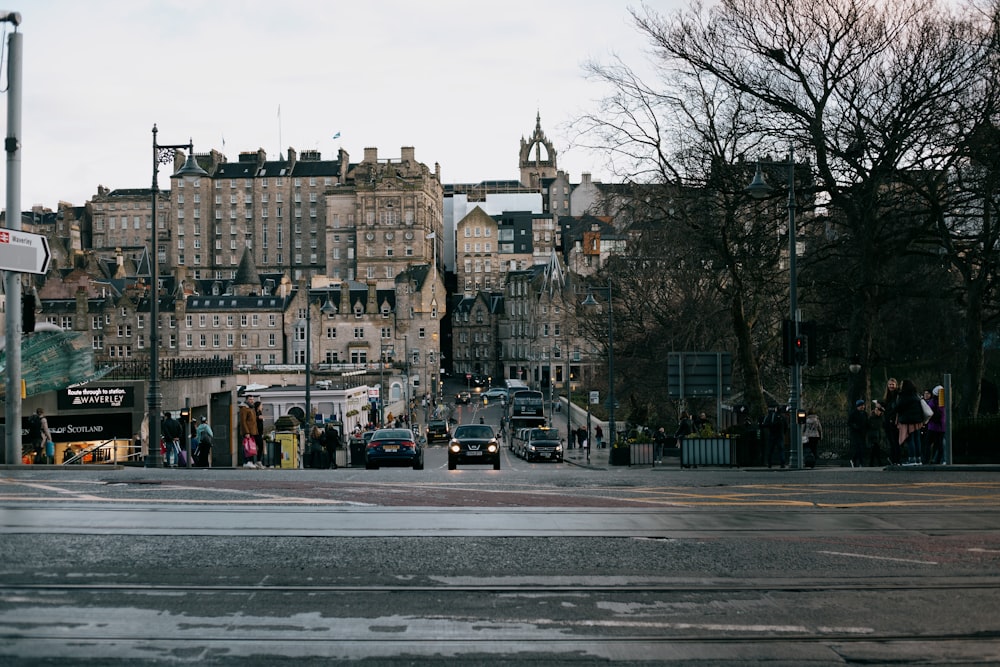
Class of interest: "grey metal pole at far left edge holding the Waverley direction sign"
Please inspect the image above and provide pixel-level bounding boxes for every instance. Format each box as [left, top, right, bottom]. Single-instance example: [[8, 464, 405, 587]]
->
[[0, 20, 22, 465]]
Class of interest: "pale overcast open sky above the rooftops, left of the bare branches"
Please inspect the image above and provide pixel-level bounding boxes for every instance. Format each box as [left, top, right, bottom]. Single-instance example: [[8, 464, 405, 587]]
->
[[9, 0, 681, 210]]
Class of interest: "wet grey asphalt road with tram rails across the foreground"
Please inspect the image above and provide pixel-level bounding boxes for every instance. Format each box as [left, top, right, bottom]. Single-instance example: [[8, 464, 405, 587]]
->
[[0, 415, 1000, 665]]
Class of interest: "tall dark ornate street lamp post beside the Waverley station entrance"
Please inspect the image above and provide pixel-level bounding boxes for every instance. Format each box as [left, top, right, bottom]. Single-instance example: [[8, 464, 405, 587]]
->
[[146, 124, 208, 468]]
